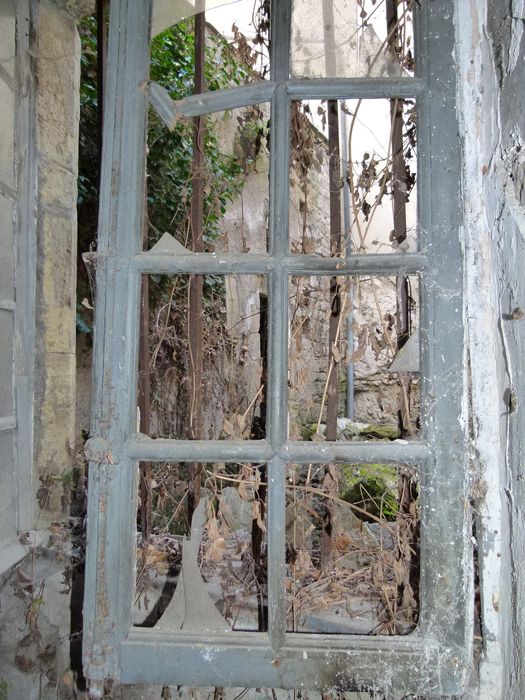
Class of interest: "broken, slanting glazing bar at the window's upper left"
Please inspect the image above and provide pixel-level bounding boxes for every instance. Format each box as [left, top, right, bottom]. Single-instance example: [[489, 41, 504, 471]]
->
[[147, 80, 276, 129]]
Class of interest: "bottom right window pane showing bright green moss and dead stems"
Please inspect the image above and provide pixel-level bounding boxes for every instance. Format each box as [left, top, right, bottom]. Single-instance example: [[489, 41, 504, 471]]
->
[[286, 464, 419, 634]]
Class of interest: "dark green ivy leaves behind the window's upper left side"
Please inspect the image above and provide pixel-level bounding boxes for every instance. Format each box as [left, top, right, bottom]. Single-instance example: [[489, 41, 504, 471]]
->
[[77, 17, 252, 333]]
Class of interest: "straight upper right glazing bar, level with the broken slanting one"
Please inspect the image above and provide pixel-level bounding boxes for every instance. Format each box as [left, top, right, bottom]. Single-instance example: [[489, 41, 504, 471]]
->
[[286, 77, 426, 100]]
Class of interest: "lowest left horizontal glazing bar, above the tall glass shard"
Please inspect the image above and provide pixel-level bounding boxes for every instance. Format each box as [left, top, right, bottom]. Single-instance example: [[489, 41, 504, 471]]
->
[[124, 436, 275, 463]]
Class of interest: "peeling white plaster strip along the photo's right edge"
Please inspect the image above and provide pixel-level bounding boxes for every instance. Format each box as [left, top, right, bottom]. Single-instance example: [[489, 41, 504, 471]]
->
[[457, 0, 525, 700]]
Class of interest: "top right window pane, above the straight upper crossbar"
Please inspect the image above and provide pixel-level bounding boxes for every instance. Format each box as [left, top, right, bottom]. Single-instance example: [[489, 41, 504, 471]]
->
[[292, 0, 416, 78]]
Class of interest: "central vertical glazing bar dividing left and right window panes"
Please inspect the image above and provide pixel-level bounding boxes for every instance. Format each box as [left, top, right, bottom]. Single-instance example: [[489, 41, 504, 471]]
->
[[258, 0, 292, 654]]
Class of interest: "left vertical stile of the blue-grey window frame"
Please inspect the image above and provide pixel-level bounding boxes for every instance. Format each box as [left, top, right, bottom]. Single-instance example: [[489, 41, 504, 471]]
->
[[84, 0, 151, 694]]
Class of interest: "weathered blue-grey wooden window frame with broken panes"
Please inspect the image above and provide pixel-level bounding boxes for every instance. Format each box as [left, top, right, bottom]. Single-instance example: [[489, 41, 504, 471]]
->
[[84, 0, 472, 696]]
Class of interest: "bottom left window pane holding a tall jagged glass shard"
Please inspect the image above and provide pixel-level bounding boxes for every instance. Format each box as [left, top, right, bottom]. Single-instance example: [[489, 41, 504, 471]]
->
[[133, 463, 267, 632]]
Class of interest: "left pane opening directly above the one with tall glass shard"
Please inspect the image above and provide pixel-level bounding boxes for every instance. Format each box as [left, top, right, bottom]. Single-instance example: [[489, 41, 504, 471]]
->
[[139, 275, 268, 440]]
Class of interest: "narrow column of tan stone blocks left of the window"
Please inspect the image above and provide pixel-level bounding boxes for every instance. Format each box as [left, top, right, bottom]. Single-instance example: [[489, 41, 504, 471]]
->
[[34, 2, 84, 519]]
